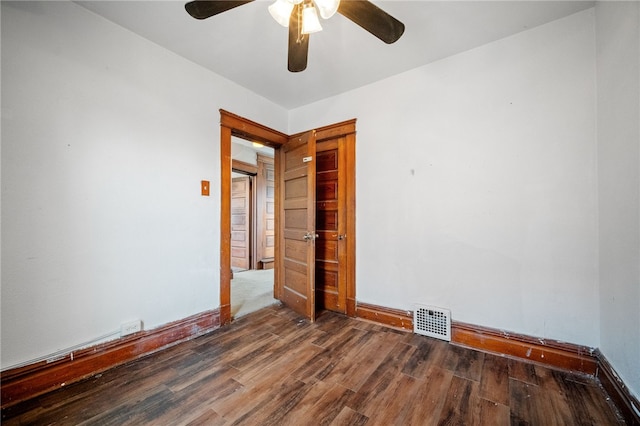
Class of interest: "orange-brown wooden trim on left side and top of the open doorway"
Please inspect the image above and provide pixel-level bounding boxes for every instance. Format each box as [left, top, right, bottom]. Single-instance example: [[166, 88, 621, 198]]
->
[[220, 109, 289, 325]]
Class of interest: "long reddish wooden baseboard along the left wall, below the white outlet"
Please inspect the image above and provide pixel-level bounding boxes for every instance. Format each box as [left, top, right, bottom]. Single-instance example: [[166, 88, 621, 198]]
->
[[0, 310, 220, 409]]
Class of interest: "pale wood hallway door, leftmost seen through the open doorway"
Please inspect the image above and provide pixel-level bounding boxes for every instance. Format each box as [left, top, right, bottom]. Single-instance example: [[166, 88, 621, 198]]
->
[[231, 176, 251, 269]]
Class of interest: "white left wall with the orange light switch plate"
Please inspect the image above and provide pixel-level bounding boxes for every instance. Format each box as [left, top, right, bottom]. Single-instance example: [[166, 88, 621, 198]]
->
[[1, 2, 287, 368]]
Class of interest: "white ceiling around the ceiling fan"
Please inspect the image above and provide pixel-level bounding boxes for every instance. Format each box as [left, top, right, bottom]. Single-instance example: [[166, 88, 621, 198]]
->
[[77, 0, 593, 109]]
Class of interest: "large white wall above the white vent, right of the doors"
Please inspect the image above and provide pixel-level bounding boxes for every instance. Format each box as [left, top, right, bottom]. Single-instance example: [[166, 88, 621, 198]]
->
[[289, 9, 600, 346]]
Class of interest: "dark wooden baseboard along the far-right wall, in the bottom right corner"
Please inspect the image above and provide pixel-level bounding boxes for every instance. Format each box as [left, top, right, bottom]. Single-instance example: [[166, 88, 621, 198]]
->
[[596, 350, 640, 426]]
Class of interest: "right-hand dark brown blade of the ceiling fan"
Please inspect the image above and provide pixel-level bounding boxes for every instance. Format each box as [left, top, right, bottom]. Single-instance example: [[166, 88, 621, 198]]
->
[[338, 0, 404, 44]]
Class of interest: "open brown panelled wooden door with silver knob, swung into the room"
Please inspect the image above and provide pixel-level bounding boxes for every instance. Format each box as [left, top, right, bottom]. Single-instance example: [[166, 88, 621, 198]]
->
[[276, 131, 316, 321]]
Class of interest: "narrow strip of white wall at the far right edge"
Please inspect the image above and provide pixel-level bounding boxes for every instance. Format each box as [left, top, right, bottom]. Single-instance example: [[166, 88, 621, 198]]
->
[[596, 2, 640, 402]]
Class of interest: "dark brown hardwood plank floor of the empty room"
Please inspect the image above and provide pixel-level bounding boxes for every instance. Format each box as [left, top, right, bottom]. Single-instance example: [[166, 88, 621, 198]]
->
[[2, 306, 624, 426]]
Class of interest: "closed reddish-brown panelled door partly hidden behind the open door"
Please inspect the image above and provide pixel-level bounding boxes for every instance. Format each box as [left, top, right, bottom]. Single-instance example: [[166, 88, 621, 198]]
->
[[315, 137, 347, 313]]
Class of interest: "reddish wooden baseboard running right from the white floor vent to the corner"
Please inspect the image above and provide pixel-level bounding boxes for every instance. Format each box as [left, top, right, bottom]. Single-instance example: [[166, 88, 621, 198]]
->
[[451, 321, 598, 375]]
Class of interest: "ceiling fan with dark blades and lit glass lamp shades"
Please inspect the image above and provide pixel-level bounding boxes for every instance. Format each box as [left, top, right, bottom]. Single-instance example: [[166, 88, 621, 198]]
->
[[185, 0, 404, 72]]
